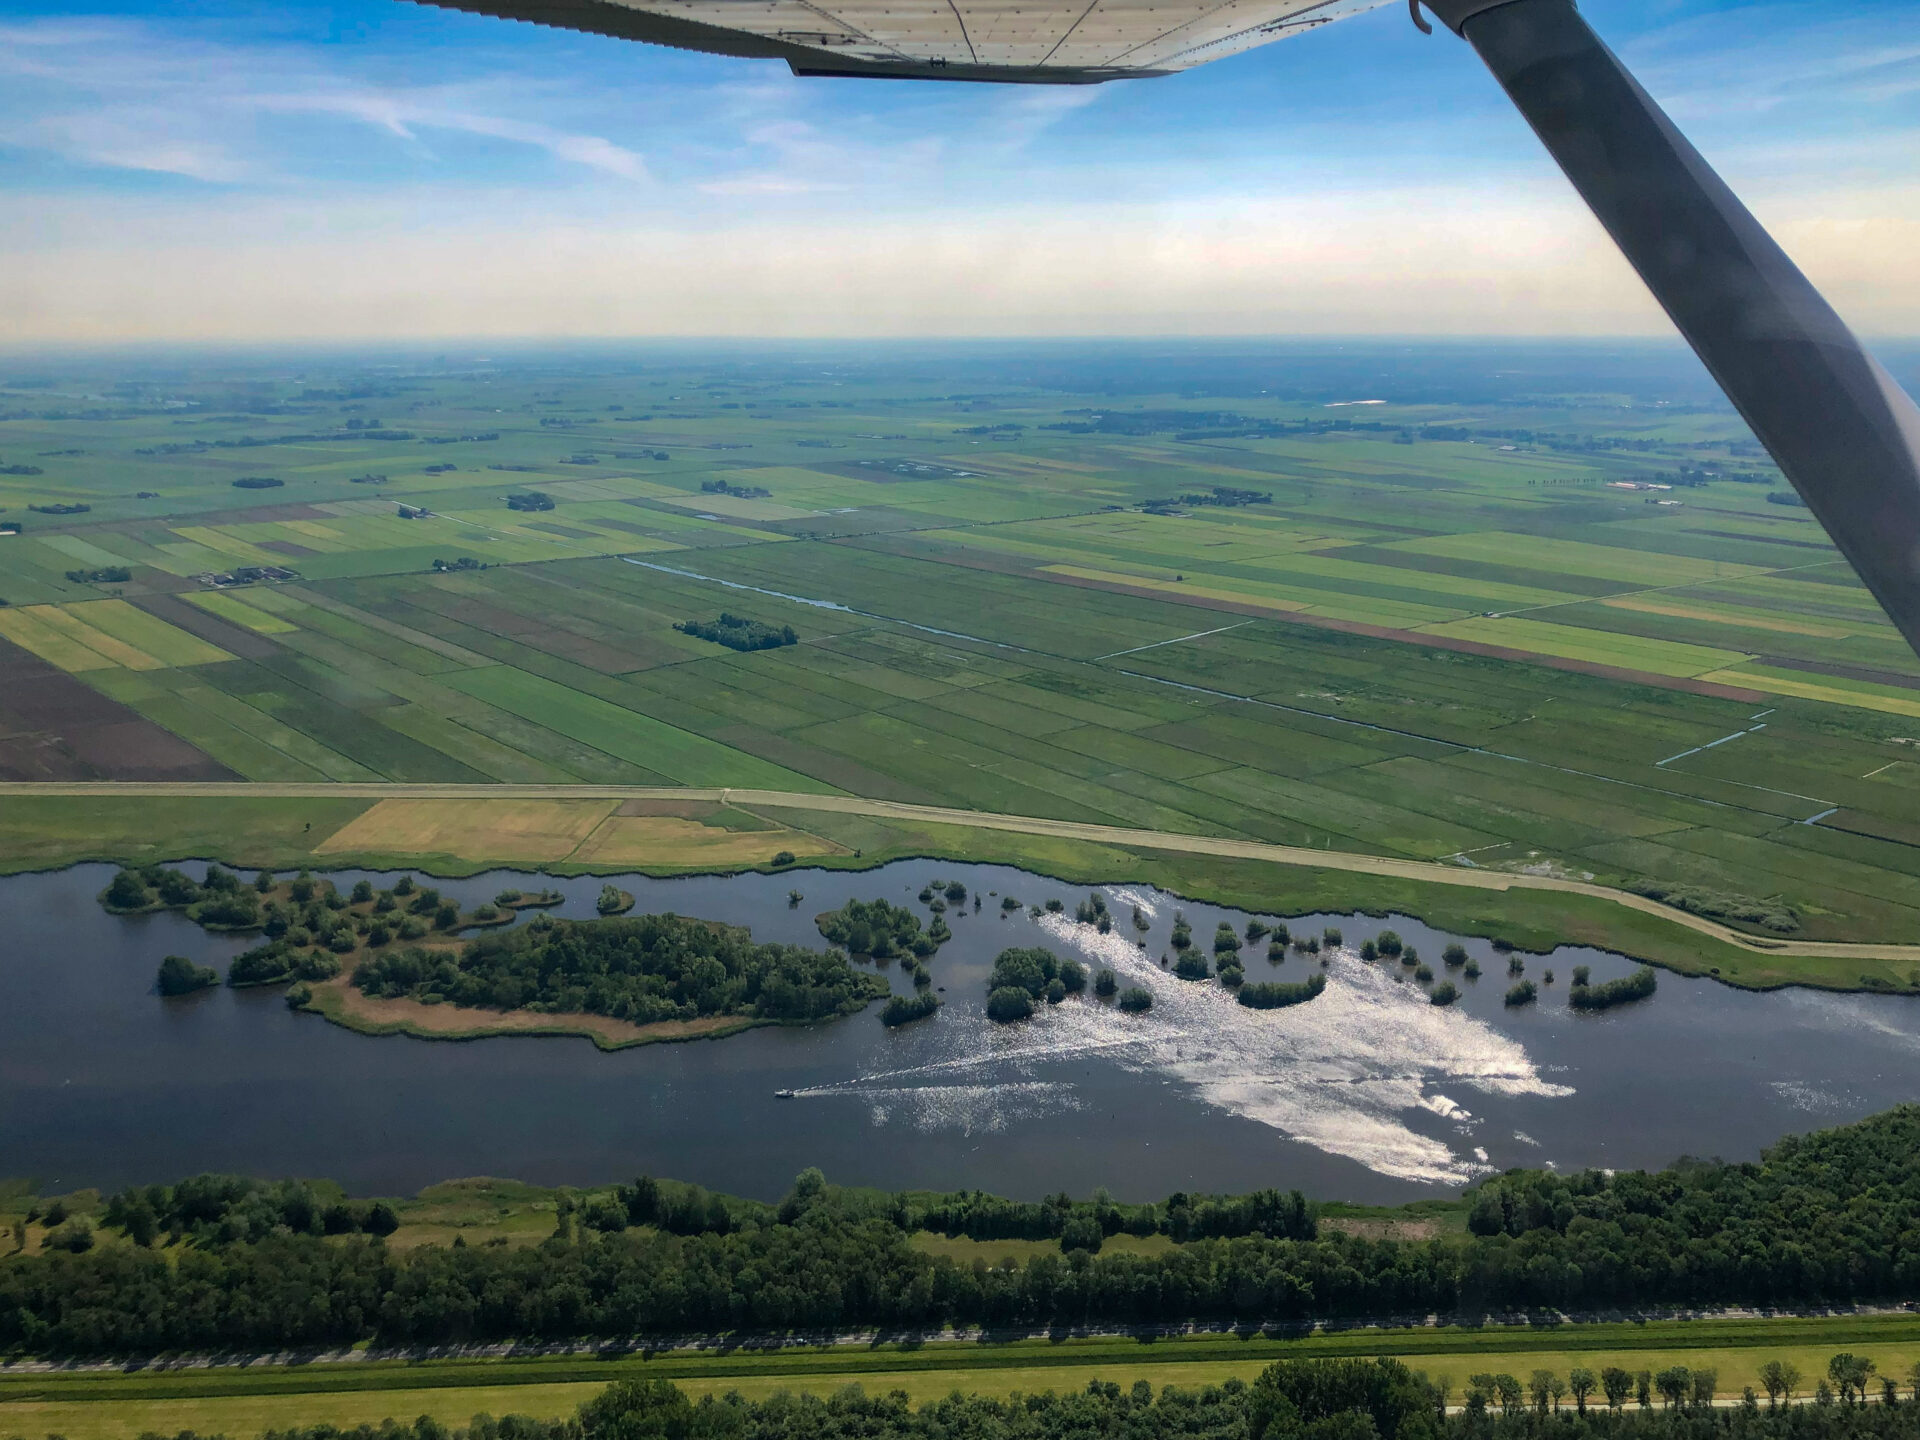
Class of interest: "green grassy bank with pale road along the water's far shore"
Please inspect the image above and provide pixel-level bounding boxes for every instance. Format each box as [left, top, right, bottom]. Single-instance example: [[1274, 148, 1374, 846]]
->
[[0, 781, 1920, 995]]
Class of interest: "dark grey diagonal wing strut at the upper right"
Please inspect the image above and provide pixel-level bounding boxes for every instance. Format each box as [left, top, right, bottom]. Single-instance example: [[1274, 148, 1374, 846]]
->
[[1425, 0, 1920, 653]]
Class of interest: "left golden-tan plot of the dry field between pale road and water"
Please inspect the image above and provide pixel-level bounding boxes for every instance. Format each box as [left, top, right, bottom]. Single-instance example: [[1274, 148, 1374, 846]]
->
[[313, 801, 616, 864]]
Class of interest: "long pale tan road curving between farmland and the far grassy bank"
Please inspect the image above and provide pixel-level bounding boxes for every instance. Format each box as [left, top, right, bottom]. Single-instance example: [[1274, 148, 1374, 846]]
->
[[0, 780, 1920, 962]]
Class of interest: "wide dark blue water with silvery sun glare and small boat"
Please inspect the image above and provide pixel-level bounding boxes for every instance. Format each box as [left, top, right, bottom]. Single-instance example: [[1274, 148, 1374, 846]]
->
[[0, 860, 1920, 1202]]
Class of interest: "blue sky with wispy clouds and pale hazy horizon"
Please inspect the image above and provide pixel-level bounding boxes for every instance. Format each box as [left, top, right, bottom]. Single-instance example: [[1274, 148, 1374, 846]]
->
[[0, 0, 1920, 348]]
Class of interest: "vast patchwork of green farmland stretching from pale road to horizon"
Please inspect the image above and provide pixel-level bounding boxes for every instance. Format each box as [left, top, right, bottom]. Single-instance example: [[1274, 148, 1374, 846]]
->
[[11, 361, 1920, 983]]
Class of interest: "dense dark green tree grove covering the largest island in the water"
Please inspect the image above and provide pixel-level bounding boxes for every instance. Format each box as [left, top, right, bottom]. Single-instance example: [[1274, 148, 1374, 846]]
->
[[353, 914, 887, 1025]]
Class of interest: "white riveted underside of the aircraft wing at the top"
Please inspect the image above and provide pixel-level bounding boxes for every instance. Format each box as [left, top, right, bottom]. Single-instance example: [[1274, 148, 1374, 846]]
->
[[412, 0, 1386, 83]]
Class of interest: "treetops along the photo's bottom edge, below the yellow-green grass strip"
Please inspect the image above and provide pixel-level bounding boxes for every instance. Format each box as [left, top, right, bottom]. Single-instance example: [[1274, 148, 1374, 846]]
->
[[82, 1359, 1920, 1440]]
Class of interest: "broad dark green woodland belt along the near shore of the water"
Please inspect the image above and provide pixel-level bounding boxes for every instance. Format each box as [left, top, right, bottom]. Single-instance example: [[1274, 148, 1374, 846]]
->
[[11, 1113, 1920, 1354]]
